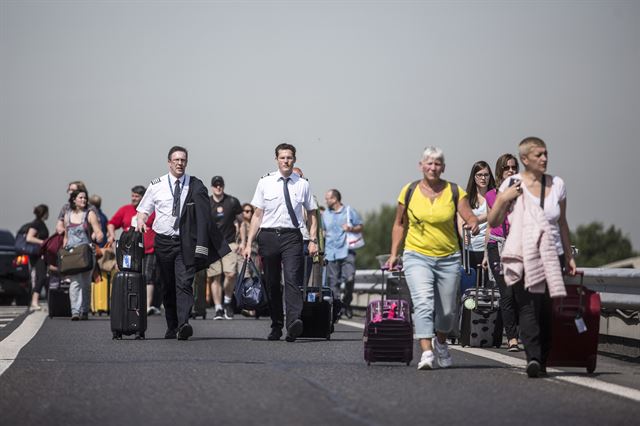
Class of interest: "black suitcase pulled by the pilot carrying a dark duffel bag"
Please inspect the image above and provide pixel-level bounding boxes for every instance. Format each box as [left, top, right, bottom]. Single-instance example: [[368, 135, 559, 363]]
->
[[300, 261, 334, 340]]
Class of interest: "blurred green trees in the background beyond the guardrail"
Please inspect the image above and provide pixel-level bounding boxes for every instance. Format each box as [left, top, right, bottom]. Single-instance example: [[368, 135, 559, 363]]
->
[[356, 205, 638, 269]]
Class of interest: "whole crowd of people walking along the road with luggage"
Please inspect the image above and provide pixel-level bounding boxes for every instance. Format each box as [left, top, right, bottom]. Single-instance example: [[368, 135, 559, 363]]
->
[[17, 137, 576, 377]]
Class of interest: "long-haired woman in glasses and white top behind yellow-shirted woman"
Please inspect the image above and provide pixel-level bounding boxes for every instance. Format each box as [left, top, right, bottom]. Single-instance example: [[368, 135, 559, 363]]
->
[[458, 161, 496, 283]]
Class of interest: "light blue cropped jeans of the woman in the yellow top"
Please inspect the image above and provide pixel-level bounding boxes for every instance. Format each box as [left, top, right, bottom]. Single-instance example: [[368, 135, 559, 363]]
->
[[402, 251, 460, 339]]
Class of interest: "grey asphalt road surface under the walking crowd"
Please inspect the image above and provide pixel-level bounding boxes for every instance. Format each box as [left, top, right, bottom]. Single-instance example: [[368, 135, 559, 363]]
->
[[0, 310, 640, 426]]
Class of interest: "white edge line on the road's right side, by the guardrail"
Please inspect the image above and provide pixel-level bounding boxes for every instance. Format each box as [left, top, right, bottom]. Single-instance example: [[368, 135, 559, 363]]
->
[[339, 320, 640, 402]]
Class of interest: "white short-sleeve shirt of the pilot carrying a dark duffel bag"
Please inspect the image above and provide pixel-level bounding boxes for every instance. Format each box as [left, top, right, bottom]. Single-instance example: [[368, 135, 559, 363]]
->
[[251, 171, 317, 228]]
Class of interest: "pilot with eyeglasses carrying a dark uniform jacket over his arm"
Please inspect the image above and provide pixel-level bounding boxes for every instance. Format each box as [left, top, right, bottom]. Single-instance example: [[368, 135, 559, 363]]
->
[[136, 146, 229, 340]]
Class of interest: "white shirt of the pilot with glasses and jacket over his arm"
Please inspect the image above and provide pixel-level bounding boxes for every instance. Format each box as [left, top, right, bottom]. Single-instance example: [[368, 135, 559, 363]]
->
[[136, 173, 191, 236]]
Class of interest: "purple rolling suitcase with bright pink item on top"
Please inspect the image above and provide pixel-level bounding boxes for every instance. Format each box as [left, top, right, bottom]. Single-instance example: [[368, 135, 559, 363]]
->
[[363, 269, 413, 365]]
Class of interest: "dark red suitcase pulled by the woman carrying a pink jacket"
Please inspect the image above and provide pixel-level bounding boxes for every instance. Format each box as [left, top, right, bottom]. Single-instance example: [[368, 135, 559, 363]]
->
[[547, 271, 600, 373]]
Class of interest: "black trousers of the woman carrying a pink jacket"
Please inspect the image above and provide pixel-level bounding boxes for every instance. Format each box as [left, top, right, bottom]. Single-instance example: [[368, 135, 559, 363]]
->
[[513, 256, 564, 365]]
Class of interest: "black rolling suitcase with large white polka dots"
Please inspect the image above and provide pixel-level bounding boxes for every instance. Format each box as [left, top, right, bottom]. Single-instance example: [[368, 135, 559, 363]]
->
[[460, 265, 503, 348]]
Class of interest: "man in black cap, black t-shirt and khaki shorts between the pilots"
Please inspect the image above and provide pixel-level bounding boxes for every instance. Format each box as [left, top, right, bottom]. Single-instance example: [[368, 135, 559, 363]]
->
[[207, 176, 242, 320]]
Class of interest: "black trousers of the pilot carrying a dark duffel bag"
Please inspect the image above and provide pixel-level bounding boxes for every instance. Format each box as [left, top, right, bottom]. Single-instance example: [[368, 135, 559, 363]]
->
[[258, 229, 304, 329]]
